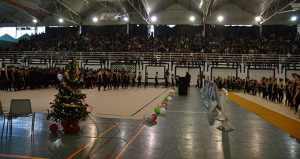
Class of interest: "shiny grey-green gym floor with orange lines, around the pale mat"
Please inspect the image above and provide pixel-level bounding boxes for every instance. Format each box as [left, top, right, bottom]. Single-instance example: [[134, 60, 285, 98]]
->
[[0, 88, 300, 159]]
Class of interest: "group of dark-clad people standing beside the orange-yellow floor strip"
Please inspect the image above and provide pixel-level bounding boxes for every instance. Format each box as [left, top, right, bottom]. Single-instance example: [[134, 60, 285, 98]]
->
[[213, 74, 300, 117]]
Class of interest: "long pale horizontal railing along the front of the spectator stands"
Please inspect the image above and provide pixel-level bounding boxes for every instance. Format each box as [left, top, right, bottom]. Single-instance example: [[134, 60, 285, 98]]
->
[[0, 51, 300, 64]]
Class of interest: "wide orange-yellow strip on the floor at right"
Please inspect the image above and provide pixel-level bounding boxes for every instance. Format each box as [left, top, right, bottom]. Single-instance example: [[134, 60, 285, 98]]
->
[[228, 92, 300, 139]]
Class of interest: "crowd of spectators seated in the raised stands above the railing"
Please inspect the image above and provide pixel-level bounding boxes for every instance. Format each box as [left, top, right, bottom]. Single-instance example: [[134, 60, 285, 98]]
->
[[0, 30, 300, 55]]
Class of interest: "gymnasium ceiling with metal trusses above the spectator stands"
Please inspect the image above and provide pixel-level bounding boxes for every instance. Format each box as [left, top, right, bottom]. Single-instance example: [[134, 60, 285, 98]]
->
[[0, 0, 300, 26]]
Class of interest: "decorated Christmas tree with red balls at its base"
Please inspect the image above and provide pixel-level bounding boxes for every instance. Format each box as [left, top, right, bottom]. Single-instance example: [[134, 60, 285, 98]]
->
[[48, 59, 89, 134]]
